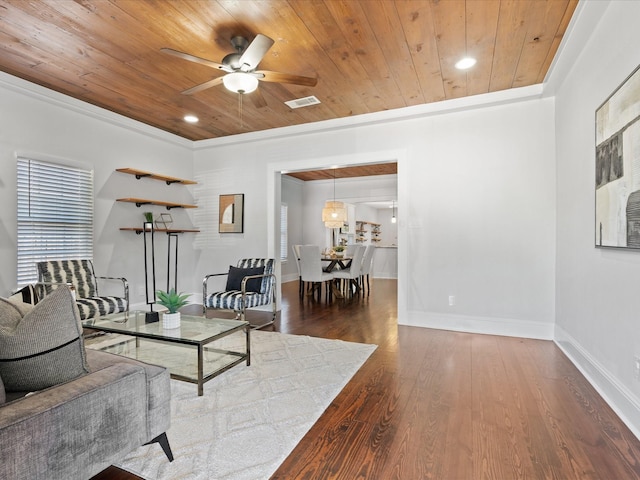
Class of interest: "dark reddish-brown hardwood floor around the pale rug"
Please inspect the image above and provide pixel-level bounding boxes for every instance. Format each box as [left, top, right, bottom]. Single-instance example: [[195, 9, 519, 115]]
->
[[95, 280, 640, 480]]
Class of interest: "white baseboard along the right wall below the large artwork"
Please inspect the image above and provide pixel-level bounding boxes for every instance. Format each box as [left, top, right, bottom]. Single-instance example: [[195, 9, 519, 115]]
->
[[554, 326, 640, 439]]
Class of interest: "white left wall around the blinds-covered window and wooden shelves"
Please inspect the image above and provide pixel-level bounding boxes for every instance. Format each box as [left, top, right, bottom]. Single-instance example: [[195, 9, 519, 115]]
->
[[0, 73, 196, 303]]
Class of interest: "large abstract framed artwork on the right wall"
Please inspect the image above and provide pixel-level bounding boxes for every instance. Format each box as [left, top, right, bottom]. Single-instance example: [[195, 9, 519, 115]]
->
[[595, 66, 640, 249]]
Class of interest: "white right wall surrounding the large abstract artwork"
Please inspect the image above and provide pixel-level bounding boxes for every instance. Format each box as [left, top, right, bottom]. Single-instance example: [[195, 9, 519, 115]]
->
[[551, 1, 640, 435]]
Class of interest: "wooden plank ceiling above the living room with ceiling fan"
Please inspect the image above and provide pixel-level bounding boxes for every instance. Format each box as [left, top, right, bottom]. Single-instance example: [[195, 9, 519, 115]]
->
[[0, 0, 577, 144]]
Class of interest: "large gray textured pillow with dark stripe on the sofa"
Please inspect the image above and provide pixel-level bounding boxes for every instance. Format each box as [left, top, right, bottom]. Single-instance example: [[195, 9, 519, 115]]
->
[[0, 286, 89, 392]]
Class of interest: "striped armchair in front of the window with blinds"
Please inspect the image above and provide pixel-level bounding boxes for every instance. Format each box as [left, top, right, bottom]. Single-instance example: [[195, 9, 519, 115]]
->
[[36, 260, 129, 320]]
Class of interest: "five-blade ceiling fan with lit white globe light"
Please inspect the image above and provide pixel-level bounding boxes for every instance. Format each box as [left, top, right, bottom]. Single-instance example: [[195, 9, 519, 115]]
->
[[160, 33, 318, 95]]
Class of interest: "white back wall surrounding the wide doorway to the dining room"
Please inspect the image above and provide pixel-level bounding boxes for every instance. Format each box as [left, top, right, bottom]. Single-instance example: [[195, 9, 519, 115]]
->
[[195, 94, 555, 338]]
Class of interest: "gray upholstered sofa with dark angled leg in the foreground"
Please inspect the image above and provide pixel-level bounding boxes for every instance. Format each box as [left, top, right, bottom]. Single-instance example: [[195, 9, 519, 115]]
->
[[0, 349, 173, 480]]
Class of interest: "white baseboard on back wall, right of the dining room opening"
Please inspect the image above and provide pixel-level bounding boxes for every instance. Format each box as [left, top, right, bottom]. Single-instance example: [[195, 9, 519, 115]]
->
[[398, 311, 553, 340]]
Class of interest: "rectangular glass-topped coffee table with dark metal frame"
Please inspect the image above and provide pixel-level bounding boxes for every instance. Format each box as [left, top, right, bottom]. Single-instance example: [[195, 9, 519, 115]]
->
[[82, 311, 251, 396]]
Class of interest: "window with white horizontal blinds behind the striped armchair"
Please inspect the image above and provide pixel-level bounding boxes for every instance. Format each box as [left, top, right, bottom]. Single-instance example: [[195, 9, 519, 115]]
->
[[17, 158, 93, 286]]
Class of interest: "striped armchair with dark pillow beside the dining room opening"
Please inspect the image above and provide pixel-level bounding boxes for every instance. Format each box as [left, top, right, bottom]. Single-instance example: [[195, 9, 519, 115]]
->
[[202, 258, 276, 328]]
